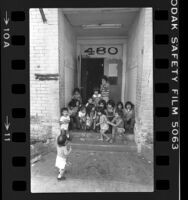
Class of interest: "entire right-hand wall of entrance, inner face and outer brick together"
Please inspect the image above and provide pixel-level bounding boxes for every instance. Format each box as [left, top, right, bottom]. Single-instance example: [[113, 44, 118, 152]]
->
[[126, 8, 153, 145]]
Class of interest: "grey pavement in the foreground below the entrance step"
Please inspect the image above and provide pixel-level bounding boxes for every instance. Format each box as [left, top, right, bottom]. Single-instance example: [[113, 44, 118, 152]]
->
[[31, 145, 153, 193]]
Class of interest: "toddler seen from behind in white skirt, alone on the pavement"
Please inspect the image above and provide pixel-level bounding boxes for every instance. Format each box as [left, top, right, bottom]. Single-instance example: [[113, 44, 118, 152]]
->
[[55, 134, 72, 180]]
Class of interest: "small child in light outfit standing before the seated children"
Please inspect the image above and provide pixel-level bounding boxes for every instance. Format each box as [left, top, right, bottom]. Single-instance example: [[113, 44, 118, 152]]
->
[[96, 108, 110, 141]]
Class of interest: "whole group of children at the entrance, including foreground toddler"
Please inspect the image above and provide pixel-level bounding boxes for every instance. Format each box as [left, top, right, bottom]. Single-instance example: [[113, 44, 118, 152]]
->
[[55, 77, 135, 179]]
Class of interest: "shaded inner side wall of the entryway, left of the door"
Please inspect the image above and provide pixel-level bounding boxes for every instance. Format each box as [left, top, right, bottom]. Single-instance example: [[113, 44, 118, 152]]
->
[[59, 10, 76, 107]]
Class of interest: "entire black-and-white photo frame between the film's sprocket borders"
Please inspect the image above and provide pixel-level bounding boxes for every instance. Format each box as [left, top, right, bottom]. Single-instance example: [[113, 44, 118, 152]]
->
[[29, 7, 154, 193]]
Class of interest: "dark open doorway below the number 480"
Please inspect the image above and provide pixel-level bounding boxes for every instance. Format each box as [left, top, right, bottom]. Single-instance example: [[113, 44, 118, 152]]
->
[[81, 58, 104, 102]]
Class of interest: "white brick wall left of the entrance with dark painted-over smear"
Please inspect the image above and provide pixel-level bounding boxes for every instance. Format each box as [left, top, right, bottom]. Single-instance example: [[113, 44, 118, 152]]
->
[[30, 9, 59, 138]]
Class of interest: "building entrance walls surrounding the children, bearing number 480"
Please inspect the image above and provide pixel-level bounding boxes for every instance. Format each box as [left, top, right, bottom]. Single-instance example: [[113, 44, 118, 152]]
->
[[30, 8, 153, 147]]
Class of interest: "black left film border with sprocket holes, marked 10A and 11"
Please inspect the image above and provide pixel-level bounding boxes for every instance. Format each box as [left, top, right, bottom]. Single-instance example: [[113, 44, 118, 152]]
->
[[1, 10, 30, 195]]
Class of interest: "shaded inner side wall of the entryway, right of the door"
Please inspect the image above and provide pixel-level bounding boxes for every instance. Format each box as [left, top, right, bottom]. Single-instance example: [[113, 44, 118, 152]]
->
[[126, 9, 145, 104]]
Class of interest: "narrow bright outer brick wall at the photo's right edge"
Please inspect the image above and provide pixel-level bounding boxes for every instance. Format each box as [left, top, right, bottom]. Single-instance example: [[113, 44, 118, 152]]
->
[[139, 8, 153, 139]]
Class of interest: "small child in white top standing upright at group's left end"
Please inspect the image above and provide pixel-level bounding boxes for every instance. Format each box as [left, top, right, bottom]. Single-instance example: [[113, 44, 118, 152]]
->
[[60, 107, 70, 138]]
